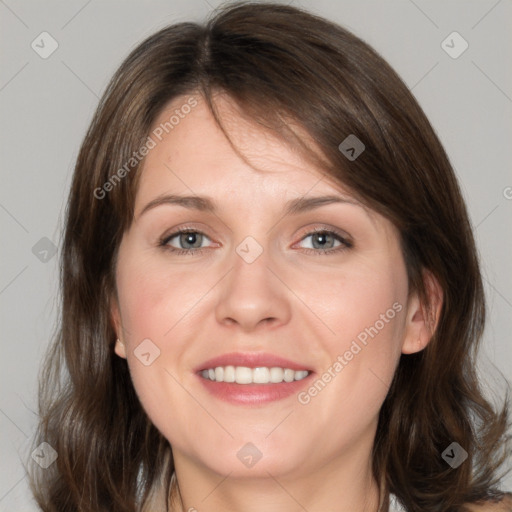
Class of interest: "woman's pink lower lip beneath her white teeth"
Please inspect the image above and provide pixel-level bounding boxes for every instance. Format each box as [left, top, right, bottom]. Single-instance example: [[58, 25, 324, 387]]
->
[[196, 372, 313, 405]]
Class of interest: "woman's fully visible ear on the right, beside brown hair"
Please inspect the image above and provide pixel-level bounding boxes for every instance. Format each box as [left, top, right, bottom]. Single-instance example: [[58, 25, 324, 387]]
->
[[402, 270, 443, 354]]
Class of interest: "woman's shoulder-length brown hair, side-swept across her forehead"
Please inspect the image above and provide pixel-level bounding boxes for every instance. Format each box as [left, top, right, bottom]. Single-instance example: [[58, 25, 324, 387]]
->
[[32, 3, 509, 512]]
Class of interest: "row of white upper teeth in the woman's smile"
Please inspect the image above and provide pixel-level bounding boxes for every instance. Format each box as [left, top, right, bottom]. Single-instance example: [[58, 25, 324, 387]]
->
[[201, 366, 309, 384]]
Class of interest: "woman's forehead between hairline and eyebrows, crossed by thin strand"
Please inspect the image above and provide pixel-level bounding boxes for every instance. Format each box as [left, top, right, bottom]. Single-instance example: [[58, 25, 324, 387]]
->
[[136, 94, 356, 210]]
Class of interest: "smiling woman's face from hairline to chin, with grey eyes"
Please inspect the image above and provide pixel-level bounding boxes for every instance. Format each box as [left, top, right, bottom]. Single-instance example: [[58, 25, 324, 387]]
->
[[112, 97, 428, 482]]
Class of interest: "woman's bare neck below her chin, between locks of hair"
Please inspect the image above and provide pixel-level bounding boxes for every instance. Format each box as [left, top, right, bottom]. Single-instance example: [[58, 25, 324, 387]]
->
[[170, 444, 383, 512]]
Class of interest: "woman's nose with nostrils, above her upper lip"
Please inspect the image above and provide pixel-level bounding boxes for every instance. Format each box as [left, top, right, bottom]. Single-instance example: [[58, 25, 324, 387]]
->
[[215, 243, 291, 332]]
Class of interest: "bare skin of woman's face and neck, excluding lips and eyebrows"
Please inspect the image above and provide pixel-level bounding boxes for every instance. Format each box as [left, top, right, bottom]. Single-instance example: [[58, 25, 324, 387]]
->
[[111, 96, 441, 512]]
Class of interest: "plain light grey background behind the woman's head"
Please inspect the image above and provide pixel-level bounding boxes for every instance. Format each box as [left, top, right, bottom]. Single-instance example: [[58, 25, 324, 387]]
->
[[0, 0, 512, 511]]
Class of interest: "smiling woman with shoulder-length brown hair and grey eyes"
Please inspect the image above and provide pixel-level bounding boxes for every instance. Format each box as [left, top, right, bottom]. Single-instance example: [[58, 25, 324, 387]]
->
[[29, 4, 512, 512]]
